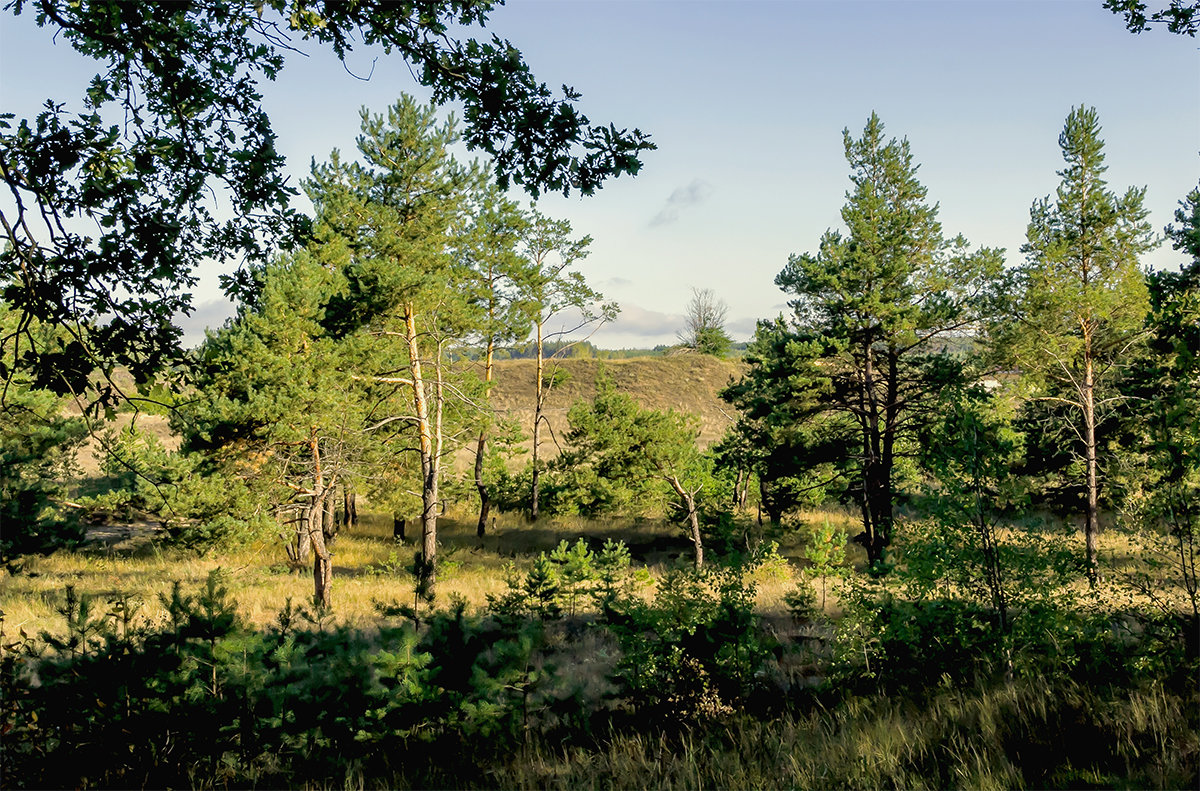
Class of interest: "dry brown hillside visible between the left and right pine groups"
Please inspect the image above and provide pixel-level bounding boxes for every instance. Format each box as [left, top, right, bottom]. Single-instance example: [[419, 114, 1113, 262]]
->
[[492, 354, 744, 455]]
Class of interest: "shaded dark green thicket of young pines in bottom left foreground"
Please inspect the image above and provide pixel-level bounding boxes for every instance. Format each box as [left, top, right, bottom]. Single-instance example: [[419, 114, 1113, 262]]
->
[[0, 573, 571, 787]]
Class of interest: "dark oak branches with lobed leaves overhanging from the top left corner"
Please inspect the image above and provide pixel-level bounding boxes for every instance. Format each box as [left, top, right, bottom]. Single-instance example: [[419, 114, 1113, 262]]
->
[[0, 0, 654, 390]]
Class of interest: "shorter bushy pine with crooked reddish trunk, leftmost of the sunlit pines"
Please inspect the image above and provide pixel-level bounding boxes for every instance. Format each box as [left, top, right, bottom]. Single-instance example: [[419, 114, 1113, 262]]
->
[[172, 251, 370, 607]]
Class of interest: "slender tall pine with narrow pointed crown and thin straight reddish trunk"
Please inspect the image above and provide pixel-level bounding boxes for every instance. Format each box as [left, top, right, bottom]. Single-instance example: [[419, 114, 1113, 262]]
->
[[995, 107, 1157, 585]]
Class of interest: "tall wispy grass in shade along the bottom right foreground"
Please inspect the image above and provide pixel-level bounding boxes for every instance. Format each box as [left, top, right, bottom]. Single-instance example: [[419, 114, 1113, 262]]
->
[[496, 679, 1200, 789]]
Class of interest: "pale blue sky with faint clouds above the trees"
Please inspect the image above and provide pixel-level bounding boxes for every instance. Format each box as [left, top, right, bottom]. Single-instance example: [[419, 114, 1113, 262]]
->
[[0, 0, 1200, 348]]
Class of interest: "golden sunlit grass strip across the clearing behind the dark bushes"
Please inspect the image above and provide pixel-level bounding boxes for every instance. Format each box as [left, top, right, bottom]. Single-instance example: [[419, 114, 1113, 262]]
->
[[0, 508, 1180, 634]]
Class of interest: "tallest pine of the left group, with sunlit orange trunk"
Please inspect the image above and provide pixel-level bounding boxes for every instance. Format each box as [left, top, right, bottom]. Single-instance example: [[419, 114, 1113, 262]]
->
[[305, 96, 482, 597]]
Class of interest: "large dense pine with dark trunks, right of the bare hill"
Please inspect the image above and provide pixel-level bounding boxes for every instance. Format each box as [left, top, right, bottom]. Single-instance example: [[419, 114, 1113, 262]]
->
[[726, 114, 1002, 563]]
